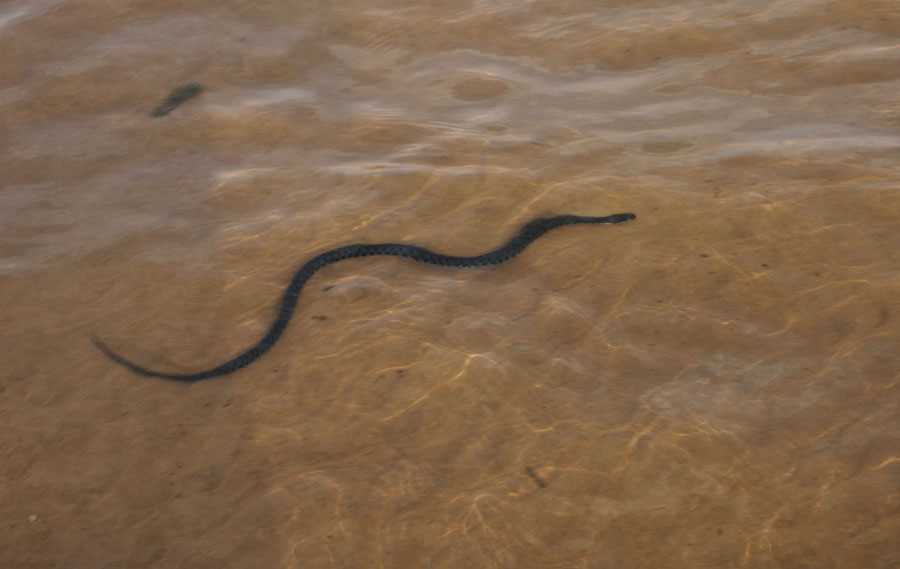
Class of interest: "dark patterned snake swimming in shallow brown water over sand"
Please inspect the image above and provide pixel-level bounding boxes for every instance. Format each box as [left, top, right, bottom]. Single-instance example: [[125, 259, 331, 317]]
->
[[92, 213, 637, 383]]
